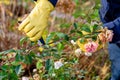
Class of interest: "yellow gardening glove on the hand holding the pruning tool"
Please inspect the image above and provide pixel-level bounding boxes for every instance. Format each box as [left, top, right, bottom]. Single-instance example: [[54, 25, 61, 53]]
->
[[18, 0, 54, 41]]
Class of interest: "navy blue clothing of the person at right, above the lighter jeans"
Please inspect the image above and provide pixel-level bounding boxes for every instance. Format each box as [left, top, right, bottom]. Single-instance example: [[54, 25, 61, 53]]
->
[[99, 0, 120, 43]]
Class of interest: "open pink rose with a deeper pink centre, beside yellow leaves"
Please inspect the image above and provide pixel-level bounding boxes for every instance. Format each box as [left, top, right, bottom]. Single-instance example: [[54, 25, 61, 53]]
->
[[84, 41, 98, 53]]
